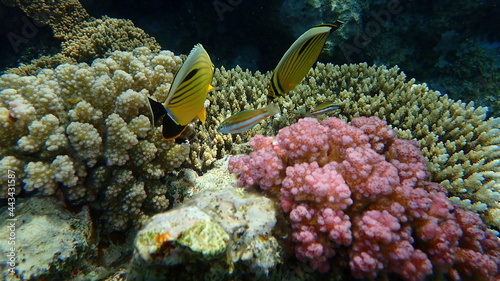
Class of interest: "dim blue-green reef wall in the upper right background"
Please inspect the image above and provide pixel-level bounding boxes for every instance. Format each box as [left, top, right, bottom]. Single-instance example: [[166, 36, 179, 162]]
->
[[279, 0, 500, 117]]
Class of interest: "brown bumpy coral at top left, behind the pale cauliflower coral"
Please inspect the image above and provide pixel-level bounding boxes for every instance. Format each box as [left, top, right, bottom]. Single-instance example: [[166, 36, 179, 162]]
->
[[3, 0, 160, 75]]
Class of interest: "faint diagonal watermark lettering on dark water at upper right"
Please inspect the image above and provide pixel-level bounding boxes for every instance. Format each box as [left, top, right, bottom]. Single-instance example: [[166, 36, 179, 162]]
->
[[339, 0, 404, 63]]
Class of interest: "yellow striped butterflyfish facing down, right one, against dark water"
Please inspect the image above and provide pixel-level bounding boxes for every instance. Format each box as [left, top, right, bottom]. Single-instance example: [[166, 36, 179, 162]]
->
[[267, 21, 343, 99]]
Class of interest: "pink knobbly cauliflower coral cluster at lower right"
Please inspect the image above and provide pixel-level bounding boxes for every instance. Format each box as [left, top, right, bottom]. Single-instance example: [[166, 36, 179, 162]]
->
[[229, 117, 500, 280]]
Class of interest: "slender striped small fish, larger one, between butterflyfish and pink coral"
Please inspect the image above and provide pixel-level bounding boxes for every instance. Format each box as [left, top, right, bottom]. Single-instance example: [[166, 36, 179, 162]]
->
[[218, 103, 280, 134]]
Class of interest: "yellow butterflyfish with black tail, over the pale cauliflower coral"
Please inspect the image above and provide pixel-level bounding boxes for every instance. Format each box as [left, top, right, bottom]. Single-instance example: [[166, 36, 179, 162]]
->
[[148, 44, 215, 139]]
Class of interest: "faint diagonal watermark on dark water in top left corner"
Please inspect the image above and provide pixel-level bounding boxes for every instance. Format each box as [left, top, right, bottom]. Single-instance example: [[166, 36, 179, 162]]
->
[[7, 13, 49, 54]]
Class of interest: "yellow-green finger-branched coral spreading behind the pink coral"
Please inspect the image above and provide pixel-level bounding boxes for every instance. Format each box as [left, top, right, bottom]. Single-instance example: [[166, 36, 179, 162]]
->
[[206, 63, 500, 229]]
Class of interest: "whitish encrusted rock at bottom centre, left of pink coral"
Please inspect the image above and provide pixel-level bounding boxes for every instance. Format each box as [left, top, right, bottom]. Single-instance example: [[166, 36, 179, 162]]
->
[[128, 185, 280, 280]]
